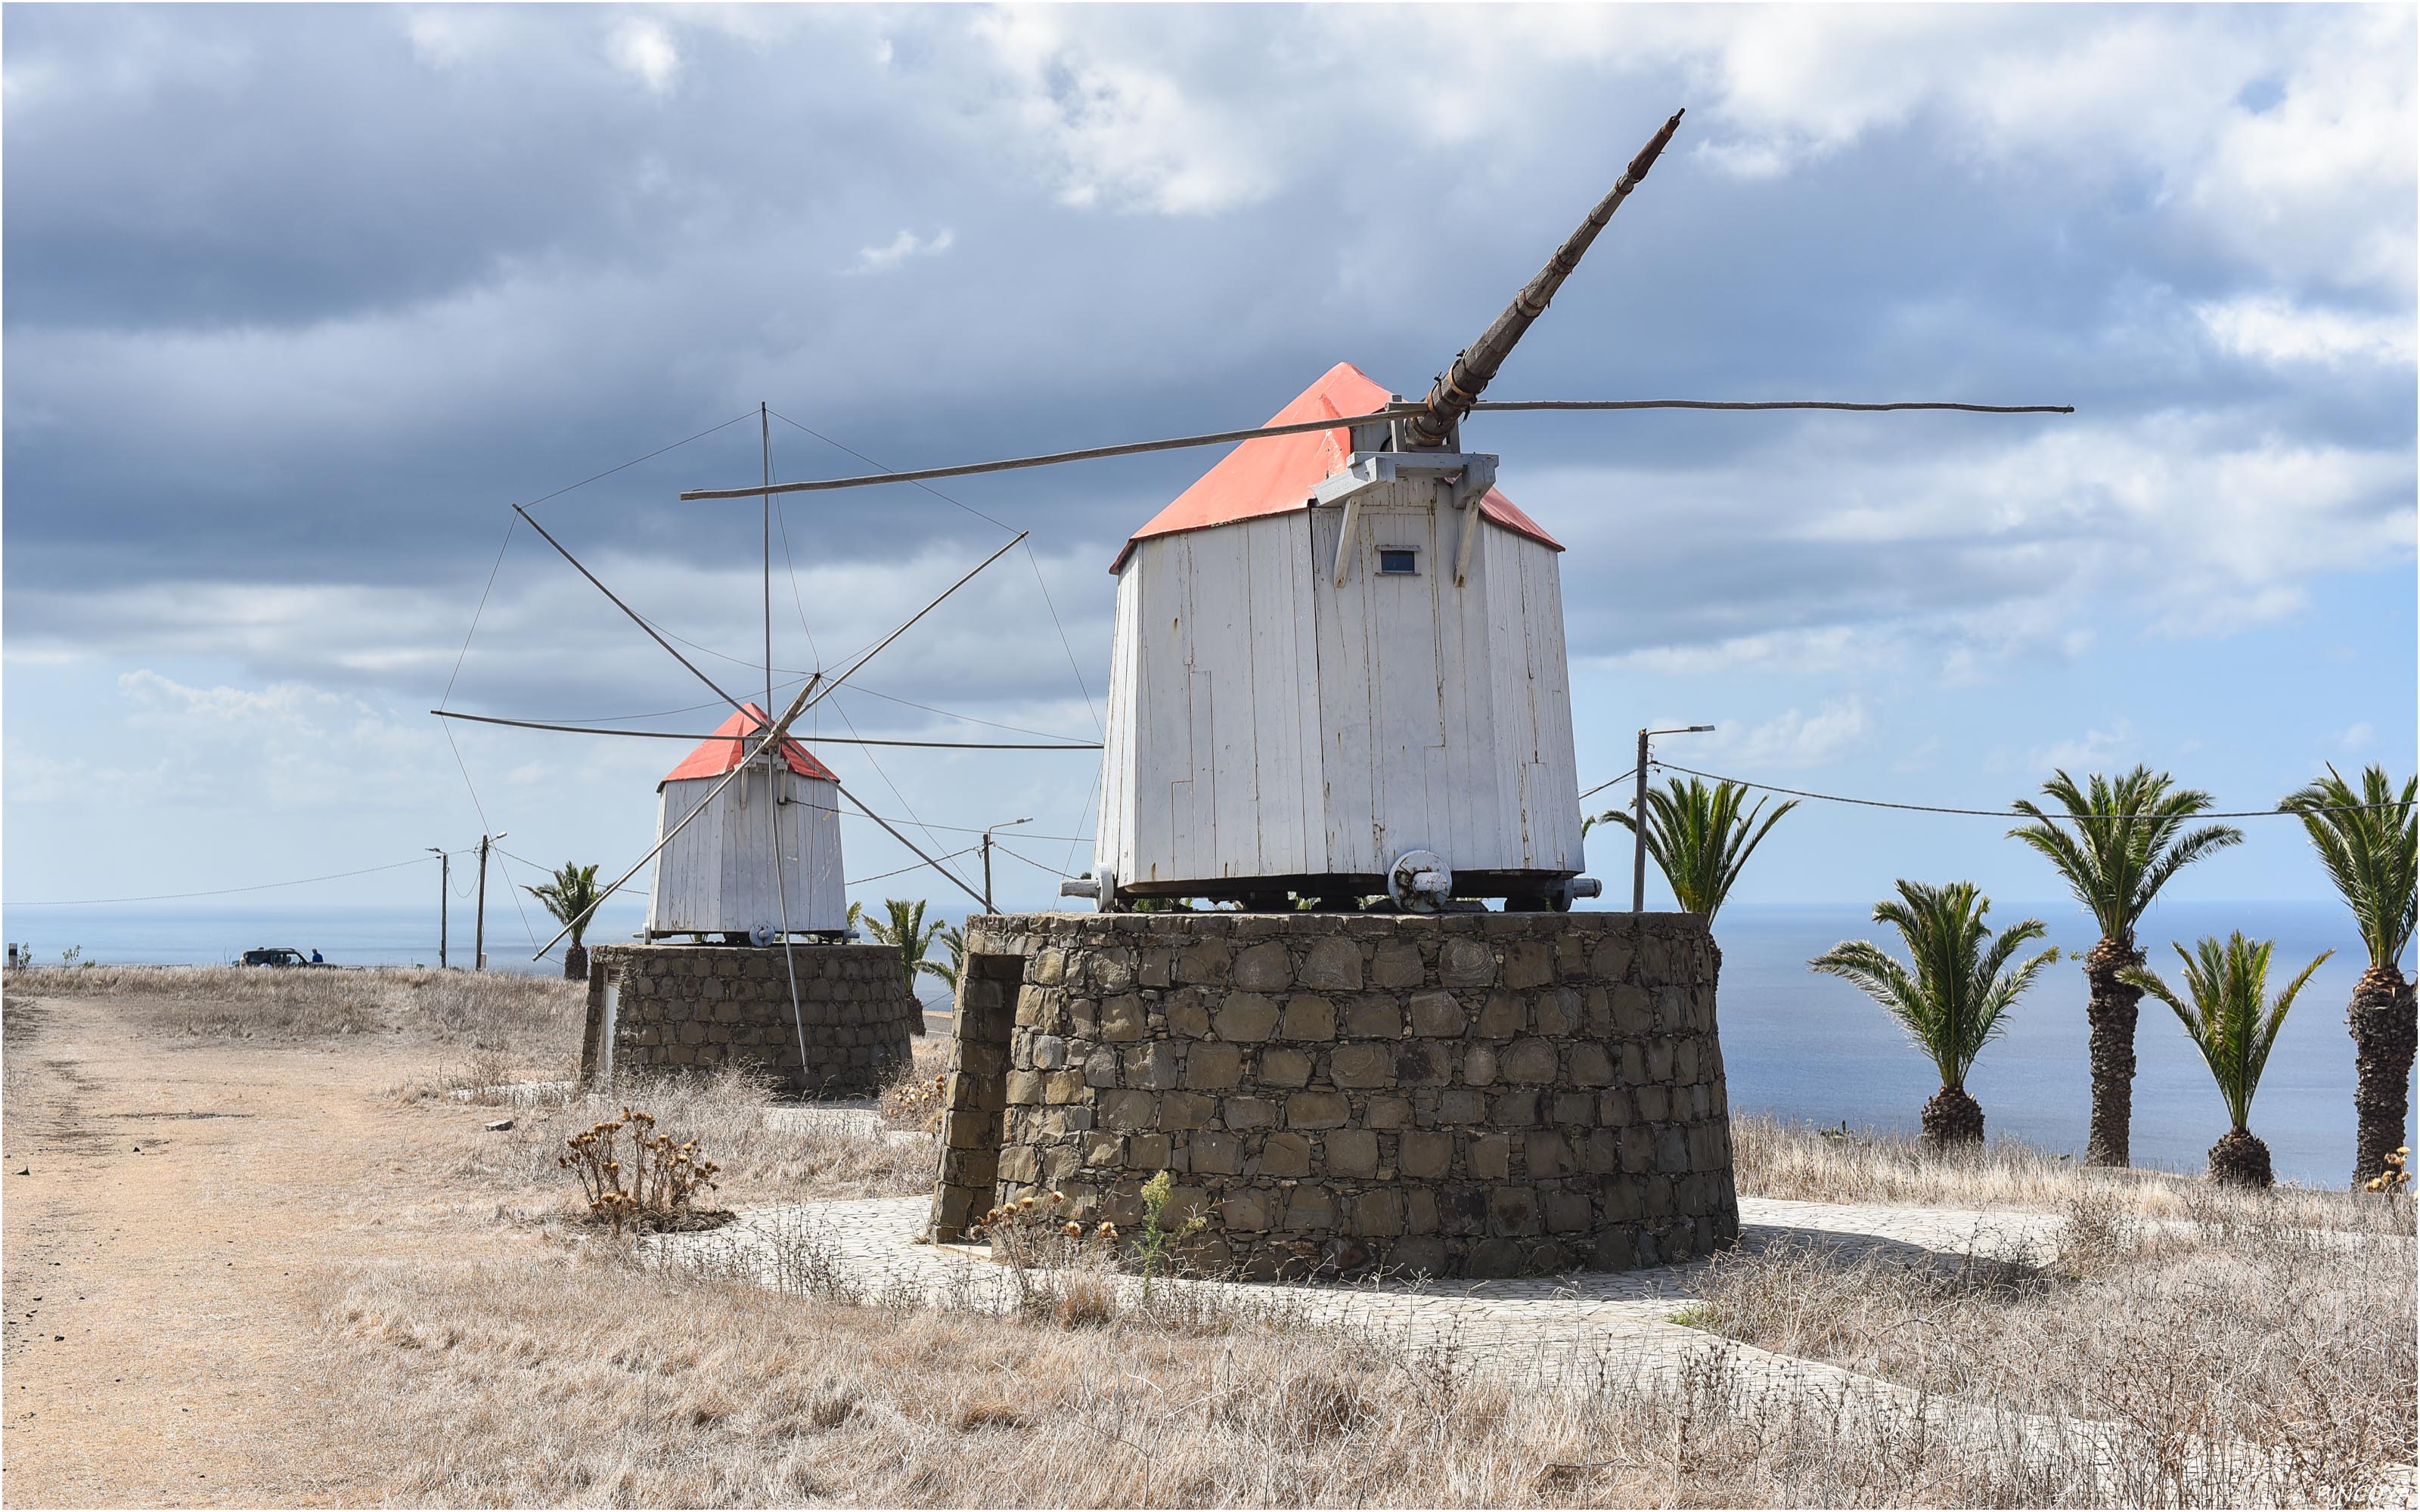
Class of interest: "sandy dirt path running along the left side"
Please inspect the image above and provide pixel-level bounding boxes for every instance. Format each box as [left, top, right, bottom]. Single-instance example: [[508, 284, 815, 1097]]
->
[[0, 996, 494, 1507]]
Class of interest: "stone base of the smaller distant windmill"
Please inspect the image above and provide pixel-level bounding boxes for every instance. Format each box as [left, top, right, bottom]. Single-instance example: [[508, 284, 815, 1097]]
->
[[581, 943, 924, 1096]]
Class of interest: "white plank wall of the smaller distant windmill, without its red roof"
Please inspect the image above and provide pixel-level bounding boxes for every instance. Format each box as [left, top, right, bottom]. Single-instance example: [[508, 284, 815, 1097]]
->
[[646, 762, 849, 934]]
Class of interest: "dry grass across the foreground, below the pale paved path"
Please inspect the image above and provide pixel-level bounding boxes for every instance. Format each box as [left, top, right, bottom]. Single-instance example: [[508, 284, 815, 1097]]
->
[[322, 1253, 2304, 1507]]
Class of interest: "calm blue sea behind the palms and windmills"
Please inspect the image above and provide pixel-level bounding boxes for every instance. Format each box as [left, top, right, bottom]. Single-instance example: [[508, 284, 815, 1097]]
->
[[0, 900, 2410, 1185]]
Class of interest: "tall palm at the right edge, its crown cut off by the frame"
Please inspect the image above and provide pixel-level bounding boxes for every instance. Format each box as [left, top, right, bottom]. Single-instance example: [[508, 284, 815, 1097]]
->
[[2279, 767, 2420, 1188]]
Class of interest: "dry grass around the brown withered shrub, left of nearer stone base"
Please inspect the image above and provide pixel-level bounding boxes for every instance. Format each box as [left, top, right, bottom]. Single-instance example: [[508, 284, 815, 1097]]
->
[[455, 1067, 939, 1219]]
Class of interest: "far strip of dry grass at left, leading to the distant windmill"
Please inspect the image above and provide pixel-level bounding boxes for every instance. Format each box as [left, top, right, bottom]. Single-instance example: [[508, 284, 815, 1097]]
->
[[8, 965, 588, 1055]]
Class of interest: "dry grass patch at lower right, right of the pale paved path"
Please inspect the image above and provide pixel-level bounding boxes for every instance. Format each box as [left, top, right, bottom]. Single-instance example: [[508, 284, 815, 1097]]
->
[[1682, 1185, 2420, 1504]]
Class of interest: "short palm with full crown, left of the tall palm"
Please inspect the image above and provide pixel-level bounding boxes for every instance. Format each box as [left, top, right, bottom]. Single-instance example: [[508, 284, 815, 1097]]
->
[[1807, 881, 2059, 1149]]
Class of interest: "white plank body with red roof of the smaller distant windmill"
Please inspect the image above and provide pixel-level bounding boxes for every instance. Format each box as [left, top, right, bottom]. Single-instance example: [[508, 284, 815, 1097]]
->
[[646, 704, 849, 943]]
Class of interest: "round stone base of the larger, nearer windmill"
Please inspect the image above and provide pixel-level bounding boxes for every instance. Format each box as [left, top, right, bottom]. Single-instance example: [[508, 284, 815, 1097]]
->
[[932, 912, 1740, 1278]]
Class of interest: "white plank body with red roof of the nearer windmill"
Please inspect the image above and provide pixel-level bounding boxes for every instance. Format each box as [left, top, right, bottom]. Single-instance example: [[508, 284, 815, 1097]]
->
[[1094, 363, 1590, 905]]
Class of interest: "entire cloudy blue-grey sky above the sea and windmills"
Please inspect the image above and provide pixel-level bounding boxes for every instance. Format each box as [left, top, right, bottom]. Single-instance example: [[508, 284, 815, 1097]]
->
[[5, 8, 2420, 934]]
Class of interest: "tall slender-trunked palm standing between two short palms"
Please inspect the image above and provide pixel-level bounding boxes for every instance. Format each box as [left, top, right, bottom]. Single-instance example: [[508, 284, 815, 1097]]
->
[[2009, 767, 2243, 1166]]
